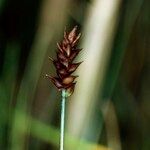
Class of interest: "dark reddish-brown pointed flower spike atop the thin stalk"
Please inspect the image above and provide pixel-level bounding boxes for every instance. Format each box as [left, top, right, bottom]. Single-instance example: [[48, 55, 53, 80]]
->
[[46, 26, 82, 96]]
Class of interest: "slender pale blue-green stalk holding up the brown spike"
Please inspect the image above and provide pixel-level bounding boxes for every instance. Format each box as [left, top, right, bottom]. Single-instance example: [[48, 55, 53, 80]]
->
[[60, 89, 66, 150]]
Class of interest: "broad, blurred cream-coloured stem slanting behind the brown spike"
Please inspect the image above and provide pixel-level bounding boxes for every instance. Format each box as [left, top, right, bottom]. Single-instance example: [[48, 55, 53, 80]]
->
[[67, 0, 121, 142]]
